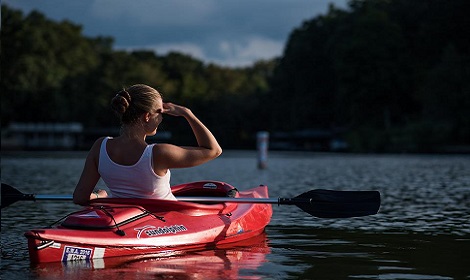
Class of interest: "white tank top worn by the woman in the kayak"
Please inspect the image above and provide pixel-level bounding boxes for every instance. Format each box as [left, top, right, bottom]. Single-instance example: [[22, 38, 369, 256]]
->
[[98, 137, 176, 200]]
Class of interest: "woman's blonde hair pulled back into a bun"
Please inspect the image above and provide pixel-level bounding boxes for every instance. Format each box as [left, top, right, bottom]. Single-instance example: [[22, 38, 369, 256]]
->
[[111, 84, 162, 124]]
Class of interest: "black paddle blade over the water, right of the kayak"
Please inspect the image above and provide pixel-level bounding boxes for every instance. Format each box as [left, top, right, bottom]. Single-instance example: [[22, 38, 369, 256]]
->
[[292, 189, 380, 218]]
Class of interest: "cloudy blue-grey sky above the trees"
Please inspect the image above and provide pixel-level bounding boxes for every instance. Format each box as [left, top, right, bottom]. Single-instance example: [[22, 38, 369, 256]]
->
[[2, 0, 348, 66]]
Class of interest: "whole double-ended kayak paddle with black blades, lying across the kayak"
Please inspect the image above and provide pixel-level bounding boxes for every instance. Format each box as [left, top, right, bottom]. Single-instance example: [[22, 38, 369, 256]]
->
[[1, 183, 380, 218]]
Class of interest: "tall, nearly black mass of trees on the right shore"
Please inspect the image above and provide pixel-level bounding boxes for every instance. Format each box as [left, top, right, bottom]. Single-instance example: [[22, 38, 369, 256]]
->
[[271, 0, 470, 152]]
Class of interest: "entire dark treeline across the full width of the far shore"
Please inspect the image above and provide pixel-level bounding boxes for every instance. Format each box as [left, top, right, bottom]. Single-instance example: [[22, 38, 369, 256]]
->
[[0, 0, 470, 152]]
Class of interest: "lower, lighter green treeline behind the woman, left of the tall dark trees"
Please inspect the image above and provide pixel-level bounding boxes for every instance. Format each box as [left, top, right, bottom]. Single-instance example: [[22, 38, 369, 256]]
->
[[1, 5, 275, 147]]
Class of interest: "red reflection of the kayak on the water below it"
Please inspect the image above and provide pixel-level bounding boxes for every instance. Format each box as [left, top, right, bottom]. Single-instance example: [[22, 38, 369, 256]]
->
[[34, 233, 271, 280]]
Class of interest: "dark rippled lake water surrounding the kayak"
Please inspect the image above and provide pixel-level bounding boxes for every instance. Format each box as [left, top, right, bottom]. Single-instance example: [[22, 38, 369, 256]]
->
[[1, 151, 470, 280]]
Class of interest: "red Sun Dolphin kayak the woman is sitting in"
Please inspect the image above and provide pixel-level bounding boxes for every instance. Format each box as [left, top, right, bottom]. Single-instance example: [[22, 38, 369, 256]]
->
[[25, 181, 272, 263]]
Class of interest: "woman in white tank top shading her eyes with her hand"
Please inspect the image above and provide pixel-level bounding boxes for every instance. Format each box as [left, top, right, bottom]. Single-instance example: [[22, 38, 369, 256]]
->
[[73, 85, 222, 205]]
